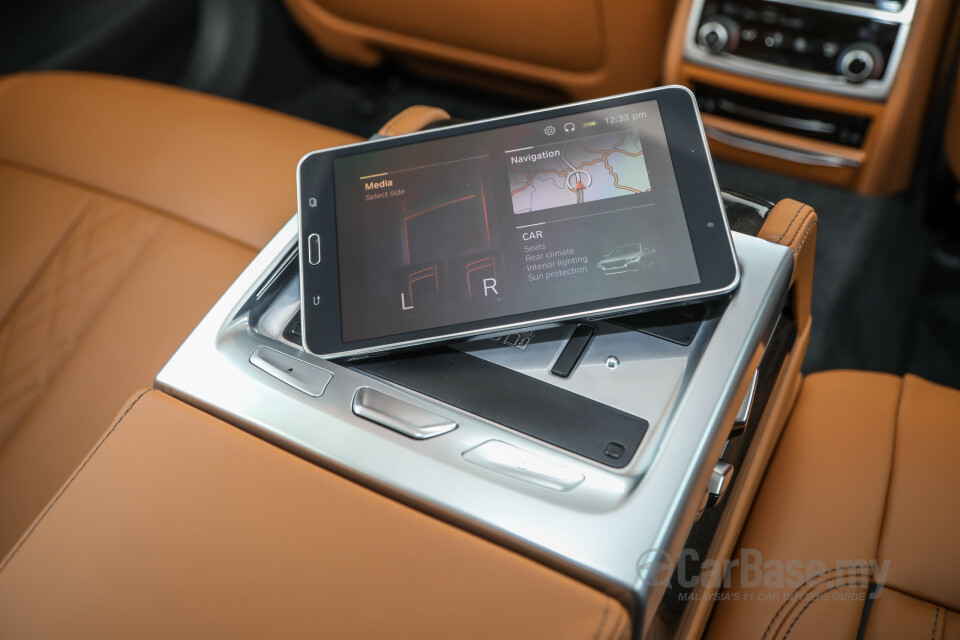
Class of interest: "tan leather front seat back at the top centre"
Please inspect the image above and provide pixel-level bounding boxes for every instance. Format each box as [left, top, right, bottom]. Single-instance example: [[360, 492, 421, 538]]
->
[[284, 0, 676, 100]]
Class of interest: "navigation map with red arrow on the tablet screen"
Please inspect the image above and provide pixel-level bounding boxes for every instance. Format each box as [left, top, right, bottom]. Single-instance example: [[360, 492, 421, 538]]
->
[[508, 130, 650, 213]]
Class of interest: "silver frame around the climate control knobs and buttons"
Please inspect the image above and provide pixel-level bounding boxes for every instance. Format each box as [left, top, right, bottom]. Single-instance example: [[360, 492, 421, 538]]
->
[[683, 0, 916, 101]]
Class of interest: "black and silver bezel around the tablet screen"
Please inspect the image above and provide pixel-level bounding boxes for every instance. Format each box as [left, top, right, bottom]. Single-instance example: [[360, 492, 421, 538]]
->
[[297, 86, 740, 358]]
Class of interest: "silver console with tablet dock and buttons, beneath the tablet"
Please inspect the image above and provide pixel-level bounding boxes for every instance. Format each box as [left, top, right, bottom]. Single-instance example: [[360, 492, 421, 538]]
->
[[157, 190, 802, 634]]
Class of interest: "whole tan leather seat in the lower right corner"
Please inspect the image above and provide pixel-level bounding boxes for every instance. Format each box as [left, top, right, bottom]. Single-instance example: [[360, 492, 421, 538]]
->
[[706, 371, 960, 640]]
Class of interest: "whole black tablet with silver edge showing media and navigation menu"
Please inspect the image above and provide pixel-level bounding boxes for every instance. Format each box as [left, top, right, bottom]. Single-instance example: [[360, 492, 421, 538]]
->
[[297, 87, 739, 358]]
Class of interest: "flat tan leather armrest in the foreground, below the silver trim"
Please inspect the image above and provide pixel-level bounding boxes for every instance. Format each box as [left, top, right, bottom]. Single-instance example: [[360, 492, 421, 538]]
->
[[0, 391, 630, 640]]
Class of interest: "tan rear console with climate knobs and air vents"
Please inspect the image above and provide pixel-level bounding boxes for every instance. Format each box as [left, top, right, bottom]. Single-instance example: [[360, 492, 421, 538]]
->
[[665, 0, 953, 194]]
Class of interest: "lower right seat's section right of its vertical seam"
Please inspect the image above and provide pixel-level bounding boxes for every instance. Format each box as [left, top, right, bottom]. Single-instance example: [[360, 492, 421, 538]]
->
[[879, 375, 960, 611]]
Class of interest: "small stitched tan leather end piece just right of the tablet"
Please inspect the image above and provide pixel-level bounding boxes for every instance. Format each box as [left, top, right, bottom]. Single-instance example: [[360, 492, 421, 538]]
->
[[759, 198, 817, 330]]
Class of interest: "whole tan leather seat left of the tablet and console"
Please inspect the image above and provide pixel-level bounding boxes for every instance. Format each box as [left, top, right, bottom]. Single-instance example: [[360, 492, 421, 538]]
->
[[0, 73, 355, 555]]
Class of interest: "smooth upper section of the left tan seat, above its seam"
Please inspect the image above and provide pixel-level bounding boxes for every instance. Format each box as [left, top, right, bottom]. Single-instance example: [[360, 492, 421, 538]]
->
[[0, 72, 358, 248]]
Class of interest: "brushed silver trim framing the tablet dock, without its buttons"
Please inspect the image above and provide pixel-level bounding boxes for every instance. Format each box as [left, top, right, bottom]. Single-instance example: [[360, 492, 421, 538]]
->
[[156, 219, 793, 634]]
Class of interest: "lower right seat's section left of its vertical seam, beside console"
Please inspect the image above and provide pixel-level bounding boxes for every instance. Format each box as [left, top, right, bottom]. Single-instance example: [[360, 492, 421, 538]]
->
[[706, 371, 901, 640]]
